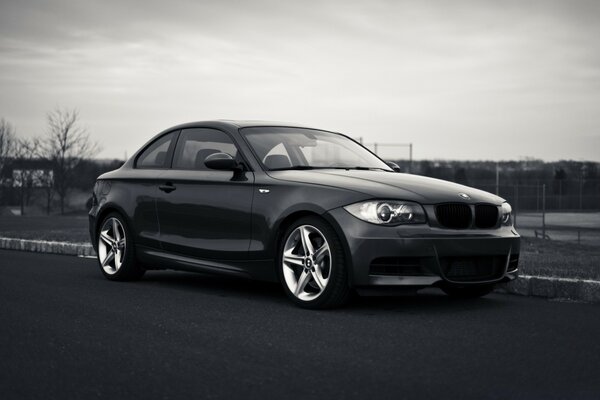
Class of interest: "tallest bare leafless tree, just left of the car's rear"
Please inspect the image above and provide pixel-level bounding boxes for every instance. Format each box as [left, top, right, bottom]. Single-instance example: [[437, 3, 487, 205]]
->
[[44, 108, 99, 214]]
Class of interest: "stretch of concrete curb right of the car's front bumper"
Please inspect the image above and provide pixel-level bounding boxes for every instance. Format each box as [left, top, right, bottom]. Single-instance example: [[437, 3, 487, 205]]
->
[[496, 275, 600, 303]]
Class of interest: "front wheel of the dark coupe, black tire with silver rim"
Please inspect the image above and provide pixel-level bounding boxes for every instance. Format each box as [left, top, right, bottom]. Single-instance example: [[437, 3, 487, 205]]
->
[[277, 217, 350, 309]]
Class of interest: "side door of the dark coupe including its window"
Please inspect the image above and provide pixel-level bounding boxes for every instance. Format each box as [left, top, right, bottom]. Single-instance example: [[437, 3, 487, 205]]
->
[[157, 128, 254, 260]]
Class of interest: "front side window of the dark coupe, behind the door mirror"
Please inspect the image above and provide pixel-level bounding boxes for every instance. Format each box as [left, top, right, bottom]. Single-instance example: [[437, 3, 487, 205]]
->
[[173, 128, 237, 171]]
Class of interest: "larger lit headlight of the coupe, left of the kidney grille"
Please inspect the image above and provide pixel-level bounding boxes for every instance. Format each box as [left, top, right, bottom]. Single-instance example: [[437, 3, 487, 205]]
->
[[344, 200, 427, 225]]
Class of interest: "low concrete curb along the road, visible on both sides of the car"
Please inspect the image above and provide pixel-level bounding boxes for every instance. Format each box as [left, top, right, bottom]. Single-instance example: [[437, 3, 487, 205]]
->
[[0, 237, 600, 303]]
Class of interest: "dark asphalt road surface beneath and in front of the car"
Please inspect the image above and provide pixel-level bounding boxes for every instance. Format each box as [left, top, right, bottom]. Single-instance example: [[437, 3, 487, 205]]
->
[[0, 251, 600, 399]]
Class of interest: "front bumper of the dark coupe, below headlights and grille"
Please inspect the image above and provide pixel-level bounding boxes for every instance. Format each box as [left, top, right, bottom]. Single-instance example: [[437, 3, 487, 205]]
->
[[327, 208, 520, 287]]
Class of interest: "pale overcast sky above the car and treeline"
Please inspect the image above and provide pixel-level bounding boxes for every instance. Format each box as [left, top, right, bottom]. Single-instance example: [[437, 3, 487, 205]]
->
[[0, 0, 600, 161]]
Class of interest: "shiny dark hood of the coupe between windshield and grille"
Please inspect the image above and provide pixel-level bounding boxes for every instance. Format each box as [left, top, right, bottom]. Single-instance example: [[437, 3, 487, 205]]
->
[[268, 169, 504, 205]]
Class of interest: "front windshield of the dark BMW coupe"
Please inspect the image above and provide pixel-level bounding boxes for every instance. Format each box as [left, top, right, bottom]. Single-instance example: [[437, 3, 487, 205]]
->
[[241, 127, 392, 171]]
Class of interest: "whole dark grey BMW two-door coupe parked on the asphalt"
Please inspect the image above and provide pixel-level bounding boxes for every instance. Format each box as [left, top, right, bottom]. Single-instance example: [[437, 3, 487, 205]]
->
[[89, 121, 520, 308]]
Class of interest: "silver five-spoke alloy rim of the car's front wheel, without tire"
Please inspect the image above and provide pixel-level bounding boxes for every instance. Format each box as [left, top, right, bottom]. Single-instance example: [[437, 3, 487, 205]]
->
[[282, 225, 332, 301]]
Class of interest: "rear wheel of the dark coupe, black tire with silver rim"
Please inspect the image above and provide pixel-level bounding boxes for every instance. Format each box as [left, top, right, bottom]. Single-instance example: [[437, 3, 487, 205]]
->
[[97, 212, 146, 281]]
